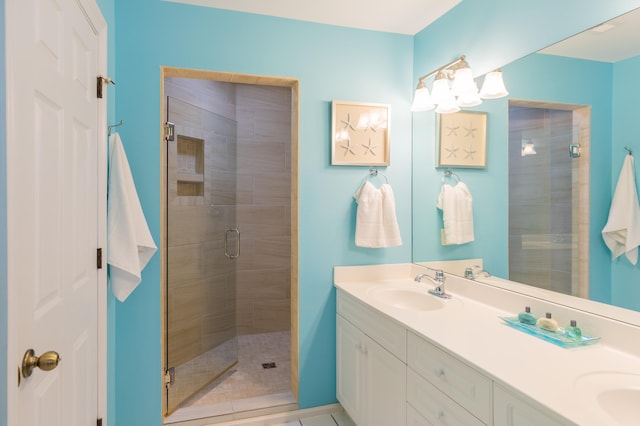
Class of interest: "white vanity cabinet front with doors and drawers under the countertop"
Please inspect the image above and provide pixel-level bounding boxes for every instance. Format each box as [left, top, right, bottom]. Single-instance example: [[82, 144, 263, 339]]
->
[[336, 282, 573, 426]]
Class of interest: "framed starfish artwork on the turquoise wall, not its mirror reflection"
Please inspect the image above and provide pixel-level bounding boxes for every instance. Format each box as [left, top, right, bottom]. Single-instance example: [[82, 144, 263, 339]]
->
[[331, 101, 389, 166]]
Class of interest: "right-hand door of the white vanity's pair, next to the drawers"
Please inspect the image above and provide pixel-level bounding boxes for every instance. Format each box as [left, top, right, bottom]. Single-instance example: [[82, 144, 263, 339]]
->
[[362, 336, 407, 426]]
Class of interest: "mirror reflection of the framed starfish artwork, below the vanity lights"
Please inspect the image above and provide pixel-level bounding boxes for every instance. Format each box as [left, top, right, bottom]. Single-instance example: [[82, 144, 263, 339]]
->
[[436, 111, 487, 168]]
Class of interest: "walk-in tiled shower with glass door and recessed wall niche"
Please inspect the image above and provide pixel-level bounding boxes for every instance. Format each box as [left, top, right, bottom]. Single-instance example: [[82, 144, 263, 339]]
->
[[165, 77, 296, 423]]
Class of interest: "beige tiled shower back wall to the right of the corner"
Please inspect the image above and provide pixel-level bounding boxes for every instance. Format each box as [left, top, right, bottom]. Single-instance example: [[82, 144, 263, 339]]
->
[[236, 85, 291, 334]]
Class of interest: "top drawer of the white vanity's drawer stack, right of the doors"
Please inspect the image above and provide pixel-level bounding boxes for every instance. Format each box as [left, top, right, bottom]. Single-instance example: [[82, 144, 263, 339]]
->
[[407, 333, 493, 424]]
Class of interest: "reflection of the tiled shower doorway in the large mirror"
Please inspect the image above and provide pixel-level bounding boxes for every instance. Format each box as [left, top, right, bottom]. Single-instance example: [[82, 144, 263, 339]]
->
[[509, 101, 588, 295]]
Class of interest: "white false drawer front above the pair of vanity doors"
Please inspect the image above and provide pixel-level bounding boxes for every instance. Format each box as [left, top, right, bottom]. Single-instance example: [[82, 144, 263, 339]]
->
[[336, 289, 407, 362]]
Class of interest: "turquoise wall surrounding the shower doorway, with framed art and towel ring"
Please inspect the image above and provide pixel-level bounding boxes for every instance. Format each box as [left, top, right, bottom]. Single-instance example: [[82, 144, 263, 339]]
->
[[114, 0, 413, 426]]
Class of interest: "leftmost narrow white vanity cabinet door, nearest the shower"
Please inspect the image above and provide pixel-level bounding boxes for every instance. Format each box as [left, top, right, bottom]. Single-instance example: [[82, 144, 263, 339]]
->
[[336, 315, 365, 424]]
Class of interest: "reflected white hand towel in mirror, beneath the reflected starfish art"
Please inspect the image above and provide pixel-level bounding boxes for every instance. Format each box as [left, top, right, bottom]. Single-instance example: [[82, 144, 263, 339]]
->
[[438, 182, 474, 244]]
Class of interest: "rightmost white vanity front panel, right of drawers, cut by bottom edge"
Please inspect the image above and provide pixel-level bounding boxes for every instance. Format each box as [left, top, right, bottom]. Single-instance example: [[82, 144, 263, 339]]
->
[[493, 384, 573, 426]]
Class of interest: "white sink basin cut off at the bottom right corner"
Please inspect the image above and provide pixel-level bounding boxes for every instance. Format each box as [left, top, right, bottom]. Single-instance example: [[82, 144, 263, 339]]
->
[[575, 371, 640, 425]]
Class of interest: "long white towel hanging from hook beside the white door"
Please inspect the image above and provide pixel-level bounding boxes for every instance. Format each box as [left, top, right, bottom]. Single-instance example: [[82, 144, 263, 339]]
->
[[107, 133, 157, 302]]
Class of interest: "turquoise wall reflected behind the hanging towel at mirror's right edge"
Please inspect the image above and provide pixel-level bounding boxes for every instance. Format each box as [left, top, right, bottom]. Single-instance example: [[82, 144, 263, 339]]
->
[[605, 56, 640, 310]]
